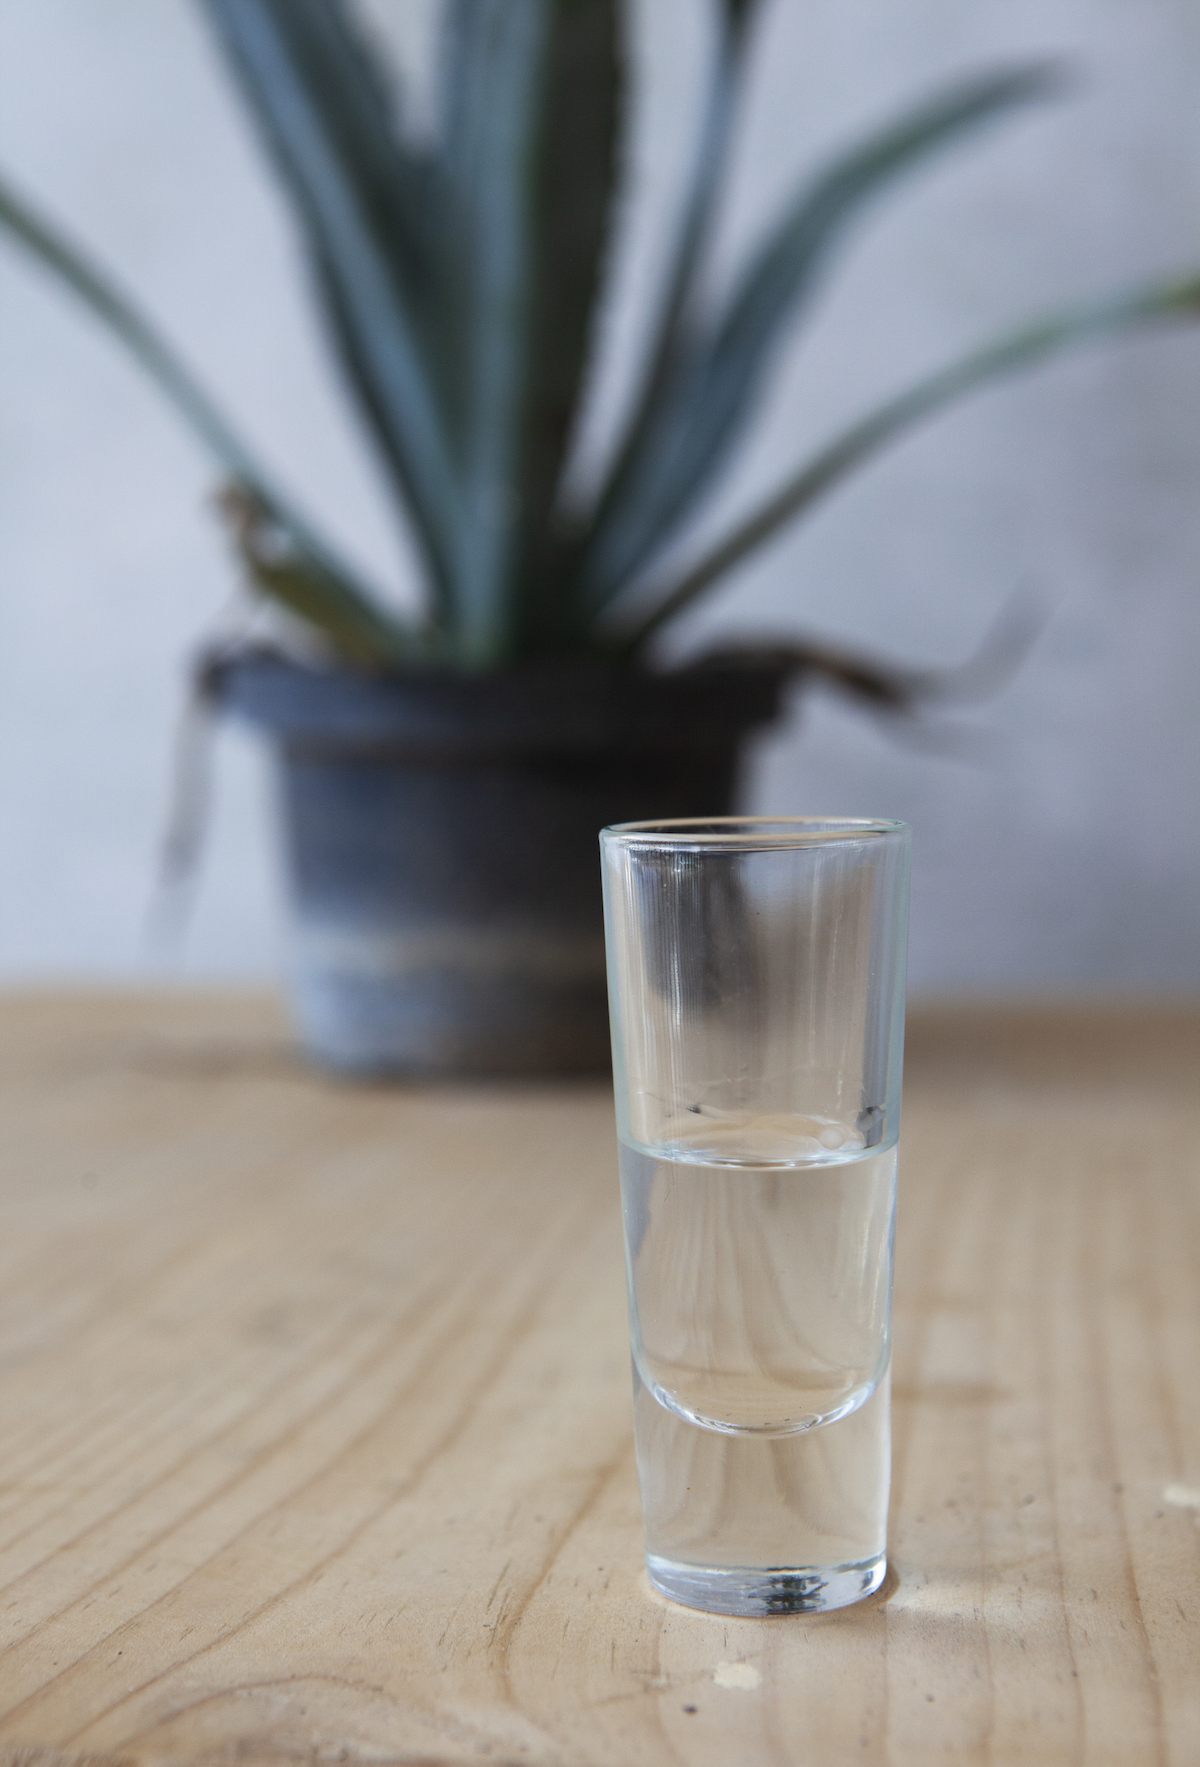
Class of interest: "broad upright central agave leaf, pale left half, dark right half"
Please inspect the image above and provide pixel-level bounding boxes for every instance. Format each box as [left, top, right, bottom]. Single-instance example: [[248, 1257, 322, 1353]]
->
[[442, 0, 620, 663]]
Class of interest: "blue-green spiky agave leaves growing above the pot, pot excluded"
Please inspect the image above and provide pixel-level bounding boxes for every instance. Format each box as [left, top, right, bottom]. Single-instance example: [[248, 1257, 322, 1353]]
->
[[0, 0, 1200, 670]]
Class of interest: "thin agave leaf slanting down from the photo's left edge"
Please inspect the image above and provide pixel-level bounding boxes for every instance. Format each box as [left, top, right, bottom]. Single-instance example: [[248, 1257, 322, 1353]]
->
[[0, 164, 412, 663]]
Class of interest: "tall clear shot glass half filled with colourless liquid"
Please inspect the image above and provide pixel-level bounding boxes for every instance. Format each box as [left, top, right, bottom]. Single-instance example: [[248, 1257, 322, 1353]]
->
[[601, 816, 908, 1615]]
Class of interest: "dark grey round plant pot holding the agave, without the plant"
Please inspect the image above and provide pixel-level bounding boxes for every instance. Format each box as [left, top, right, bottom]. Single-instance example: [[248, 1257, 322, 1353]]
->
[[212, 654, 790, 1074]]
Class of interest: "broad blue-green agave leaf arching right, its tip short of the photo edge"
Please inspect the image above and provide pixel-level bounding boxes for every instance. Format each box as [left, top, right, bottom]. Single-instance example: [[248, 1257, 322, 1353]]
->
[[581, 65, 1059, 611]]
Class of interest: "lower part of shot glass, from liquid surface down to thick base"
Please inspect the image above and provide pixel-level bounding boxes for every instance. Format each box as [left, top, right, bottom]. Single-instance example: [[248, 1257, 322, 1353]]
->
[[620, 1119, 896, 1613]]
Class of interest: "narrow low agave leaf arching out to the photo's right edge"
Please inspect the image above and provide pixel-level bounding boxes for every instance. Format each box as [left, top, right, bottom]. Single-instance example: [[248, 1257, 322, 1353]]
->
[[617, 274, 1200, 652]]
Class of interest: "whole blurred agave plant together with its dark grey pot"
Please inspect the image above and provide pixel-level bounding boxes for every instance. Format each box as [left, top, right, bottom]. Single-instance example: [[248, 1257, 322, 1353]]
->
[[0, 0, 1200, 1073]]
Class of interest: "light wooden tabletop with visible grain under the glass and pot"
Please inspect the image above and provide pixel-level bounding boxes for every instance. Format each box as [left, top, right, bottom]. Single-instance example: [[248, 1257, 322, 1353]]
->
[[0, 995, 1200, 1767]]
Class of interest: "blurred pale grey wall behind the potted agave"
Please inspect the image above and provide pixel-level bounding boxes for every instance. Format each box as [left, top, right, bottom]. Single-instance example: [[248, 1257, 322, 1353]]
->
[[0, 0, 1200, 995]]
